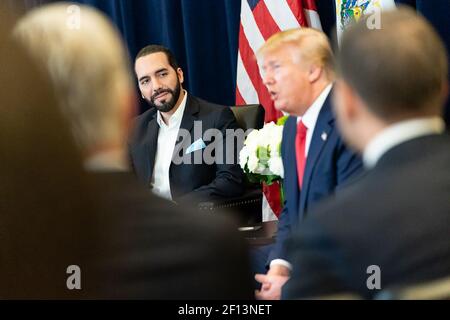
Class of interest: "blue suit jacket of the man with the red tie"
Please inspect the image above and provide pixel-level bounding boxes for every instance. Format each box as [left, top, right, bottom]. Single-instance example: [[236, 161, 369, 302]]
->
[[268, 93, 362, 263]]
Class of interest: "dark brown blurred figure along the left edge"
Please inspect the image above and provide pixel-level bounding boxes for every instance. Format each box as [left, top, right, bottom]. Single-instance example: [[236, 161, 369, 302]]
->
[[0, 10, 98, 299]]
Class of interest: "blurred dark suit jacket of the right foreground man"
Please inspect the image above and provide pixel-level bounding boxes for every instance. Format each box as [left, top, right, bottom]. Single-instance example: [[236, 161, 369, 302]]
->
[[283, 134, 450, 299]]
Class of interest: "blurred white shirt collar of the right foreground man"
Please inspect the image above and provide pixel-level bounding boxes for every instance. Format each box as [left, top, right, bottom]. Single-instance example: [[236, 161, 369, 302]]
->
[[363, 117, 445, 169]]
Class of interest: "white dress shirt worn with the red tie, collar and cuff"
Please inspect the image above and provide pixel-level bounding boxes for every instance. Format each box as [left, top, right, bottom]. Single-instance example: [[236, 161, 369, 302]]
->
[[270, 83, 333, 270]]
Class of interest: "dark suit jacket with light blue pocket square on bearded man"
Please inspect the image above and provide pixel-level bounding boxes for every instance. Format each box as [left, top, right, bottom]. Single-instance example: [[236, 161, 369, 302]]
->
[[129, 94, 244, 202]]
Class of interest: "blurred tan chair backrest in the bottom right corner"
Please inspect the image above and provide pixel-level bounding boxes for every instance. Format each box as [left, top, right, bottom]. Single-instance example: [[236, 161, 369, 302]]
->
[[375, 277, 450, 300]]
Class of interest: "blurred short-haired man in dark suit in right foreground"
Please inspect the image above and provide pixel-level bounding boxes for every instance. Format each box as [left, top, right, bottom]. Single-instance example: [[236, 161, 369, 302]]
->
[[283, 8, 450, 298]]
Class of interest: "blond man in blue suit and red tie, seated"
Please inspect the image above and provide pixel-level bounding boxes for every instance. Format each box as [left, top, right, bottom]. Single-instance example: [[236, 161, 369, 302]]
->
[[256, 28, 361, 299]]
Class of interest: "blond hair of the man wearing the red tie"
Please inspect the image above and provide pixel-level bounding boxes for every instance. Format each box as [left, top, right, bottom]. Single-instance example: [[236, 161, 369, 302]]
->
[[256, 28, 334, 80]]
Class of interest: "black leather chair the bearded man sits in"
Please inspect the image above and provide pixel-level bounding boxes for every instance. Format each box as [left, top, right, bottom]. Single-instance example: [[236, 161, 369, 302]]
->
[[199, 104, 265, 225]]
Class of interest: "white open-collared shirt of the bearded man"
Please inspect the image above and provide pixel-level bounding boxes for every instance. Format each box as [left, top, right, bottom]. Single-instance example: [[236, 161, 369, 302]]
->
[[151, 91, 187, 200]]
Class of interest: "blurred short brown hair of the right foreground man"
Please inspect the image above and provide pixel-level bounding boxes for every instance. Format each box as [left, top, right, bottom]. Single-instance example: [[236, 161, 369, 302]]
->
[[337, 7, 448, 121]]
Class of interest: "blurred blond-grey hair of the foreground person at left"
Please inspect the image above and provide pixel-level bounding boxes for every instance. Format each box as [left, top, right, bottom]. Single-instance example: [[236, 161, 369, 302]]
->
[[15, 3, 132, 151]]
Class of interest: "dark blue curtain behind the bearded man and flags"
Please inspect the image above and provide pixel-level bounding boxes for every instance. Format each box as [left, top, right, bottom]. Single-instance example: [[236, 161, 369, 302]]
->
[[7, 0, 450, 123]]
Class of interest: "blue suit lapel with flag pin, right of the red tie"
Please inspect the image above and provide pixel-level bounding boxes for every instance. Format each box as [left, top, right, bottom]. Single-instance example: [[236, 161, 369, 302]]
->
[[299, 93, 334, 218]]
